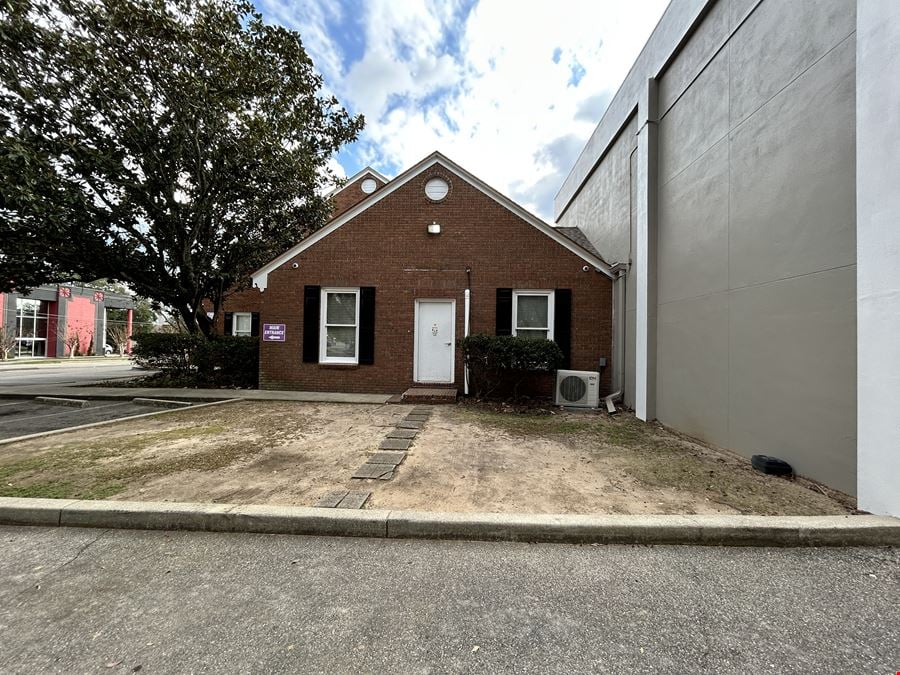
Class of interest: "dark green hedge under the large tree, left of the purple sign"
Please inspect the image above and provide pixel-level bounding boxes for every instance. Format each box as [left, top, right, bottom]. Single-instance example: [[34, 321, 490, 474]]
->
[[133, 333, 259, 387]]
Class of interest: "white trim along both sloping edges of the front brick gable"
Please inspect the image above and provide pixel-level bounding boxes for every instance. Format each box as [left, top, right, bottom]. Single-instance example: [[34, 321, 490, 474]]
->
[[252, 152, 613, 290]]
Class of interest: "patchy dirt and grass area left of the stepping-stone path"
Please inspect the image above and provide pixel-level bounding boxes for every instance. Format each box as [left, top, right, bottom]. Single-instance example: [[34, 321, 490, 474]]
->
[[0, 402, 410, 505]]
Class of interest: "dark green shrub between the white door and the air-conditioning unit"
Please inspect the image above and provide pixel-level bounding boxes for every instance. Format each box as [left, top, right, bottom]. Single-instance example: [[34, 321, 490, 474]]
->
[[459, 334, 564, 398]]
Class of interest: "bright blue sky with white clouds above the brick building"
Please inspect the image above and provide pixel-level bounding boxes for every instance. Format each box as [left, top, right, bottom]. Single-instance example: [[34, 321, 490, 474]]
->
[[256, 0, 668, 221]]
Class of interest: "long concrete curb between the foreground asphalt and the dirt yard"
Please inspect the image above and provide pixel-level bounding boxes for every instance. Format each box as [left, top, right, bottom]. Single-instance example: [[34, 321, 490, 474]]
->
[[0, 498, 900, 546]]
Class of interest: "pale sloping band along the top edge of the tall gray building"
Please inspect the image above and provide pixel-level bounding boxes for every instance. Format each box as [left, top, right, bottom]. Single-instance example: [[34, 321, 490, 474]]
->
[[553, 0, 717, 221]]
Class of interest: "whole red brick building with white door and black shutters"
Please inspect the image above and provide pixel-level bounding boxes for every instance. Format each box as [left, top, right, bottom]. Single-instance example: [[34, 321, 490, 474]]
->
[[223, 153, 613, 393]]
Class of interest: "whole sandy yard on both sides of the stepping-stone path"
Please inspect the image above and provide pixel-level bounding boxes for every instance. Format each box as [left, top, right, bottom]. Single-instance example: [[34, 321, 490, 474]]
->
[[0, 402, 853, 515]]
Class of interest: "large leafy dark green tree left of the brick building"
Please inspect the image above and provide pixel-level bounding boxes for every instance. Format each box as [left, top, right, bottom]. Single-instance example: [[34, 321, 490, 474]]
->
[[0, 0, 363, 333]]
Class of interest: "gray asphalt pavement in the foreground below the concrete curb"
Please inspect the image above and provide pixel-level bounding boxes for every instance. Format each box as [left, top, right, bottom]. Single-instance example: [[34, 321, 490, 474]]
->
[[0, 527, 900, 675]]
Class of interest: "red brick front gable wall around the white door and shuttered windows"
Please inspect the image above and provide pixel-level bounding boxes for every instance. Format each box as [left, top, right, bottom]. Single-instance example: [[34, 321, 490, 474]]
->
[[260, 170, 612, 393]]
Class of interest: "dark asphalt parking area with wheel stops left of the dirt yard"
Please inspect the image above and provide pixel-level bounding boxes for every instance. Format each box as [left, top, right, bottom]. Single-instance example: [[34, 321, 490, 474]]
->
[[0, 398, 158, 440]]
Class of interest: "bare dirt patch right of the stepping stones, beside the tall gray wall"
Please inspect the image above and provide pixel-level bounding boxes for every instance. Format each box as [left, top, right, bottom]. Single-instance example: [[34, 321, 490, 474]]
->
[[362, 405, 854, 515]]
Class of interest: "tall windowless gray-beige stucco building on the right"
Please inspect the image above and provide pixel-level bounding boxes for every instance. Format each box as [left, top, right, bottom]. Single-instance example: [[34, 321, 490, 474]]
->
[[555, 0, 900, 514]]
